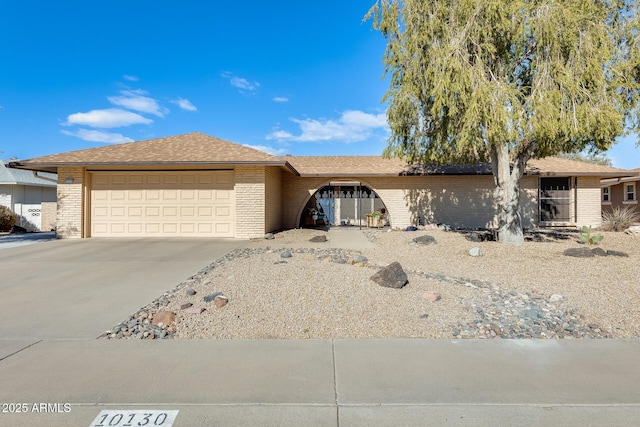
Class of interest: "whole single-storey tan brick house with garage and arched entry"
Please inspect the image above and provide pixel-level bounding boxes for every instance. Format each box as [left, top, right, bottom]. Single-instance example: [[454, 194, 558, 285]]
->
[[12, 133, 624, 238]]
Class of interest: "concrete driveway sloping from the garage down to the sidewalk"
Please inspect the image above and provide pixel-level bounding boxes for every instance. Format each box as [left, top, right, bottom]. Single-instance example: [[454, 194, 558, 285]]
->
[[0, 239, 245, 346]]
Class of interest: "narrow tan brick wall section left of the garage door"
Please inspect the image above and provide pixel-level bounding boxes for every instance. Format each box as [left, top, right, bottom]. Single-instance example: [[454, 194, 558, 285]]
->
[[56, 167, 85, 239]]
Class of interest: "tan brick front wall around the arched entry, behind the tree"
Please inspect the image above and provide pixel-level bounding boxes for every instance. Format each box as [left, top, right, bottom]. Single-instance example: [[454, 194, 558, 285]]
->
[[282, 175, 538, 232]]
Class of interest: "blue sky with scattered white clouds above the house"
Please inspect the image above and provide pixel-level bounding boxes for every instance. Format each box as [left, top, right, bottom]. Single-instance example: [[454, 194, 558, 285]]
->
[[0, 0, 640, 168]]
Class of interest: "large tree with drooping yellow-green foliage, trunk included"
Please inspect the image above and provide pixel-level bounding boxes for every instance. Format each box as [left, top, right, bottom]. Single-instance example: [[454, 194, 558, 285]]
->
[[366, 0, 640, 243]]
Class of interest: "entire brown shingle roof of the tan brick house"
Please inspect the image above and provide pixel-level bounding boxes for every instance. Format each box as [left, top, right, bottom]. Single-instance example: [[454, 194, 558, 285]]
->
[[12, 132, 629, 177]]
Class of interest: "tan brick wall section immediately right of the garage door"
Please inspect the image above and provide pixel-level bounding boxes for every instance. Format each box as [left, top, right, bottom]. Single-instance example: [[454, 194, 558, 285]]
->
[[235, 166, 266, 239]]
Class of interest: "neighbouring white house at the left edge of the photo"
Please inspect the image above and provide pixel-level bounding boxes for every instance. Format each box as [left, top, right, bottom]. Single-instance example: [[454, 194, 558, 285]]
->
[[0, 161, 57, 231]]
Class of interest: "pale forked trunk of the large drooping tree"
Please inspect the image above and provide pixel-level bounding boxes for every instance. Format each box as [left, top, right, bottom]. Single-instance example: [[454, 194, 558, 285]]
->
[[491, 144, 526, 245]]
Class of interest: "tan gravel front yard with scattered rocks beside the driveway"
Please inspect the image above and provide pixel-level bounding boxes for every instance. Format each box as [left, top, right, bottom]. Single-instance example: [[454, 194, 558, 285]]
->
[[97, 229, 640, 339]]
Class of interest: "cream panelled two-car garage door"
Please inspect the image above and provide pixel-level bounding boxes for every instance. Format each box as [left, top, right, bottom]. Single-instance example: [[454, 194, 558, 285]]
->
[[90, 171, 235, 237]]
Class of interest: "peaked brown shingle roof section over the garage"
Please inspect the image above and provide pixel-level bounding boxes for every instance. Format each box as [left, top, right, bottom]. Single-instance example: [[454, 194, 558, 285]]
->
[[16, 132, 286, 167]]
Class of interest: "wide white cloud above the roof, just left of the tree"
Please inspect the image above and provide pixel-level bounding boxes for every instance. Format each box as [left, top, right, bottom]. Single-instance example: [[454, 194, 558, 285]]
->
[[266, 110, 389, 142]]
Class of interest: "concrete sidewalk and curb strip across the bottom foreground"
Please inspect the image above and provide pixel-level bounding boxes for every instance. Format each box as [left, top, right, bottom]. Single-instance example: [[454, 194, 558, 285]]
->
[[0, 339, 640, 426]]
